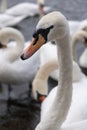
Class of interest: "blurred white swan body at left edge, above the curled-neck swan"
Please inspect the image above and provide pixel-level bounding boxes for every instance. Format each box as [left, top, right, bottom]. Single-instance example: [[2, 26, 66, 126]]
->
[[0, 13, 25, 28]]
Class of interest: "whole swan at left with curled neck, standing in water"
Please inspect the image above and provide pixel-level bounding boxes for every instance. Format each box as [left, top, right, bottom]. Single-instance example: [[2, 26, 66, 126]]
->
[[0, 27, 39, 99]]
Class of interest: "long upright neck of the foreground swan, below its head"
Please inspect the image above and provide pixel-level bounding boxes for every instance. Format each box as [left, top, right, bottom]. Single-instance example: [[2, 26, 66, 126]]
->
[[52, 31, 72, 130]]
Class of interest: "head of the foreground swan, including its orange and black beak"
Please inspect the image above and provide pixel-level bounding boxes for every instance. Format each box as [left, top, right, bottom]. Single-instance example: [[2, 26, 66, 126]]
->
[[21, 11, 68, 60]]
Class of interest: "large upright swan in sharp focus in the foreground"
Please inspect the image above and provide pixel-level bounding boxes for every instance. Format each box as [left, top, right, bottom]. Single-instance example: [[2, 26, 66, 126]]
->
[[21, 11, 87, 130]]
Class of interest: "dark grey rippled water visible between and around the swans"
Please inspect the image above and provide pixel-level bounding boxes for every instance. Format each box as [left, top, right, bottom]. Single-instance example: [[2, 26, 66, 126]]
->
[[0, 0, 87, 130]]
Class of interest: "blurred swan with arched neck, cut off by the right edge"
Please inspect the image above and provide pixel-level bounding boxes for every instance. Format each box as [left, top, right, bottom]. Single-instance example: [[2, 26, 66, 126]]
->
[[72, 30, 87, 71]]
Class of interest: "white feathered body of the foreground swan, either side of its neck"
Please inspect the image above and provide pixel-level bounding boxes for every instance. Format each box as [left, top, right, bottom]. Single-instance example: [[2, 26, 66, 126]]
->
[[41, 72, 87, 125]]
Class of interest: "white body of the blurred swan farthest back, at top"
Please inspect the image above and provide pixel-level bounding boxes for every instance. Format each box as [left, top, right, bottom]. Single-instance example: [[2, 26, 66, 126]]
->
[[5, 2, 51, 17]]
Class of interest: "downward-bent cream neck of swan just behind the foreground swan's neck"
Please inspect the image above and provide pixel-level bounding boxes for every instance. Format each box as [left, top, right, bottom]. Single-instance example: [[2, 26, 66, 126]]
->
[[32, 60, 58, 99]]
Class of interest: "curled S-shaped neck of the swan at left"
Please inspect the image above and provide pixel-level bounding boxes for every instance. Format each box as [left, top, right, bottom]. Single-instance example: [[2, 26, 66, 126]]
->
[[3, 28, 24, 62]]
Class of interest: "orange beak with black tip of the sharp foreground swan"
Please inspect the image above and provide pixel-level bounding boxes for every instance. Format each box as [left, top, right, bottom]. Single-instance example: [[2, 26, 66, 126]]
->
[[21, 34, 45, 60]]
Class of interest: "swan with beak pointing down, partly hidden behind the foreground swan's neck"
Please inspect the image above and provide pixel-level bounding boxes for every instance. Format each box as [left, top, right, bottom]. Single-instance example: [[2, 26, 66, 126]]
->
[[32, 59, 85, 102]]
